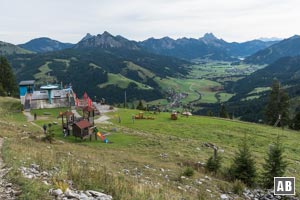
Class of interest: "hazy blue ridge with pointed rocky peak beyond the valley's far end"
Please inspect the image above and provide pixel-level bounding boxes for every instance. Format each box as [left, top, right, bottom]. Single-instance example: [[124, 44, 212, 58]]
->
[[139, 33, 278, 61]]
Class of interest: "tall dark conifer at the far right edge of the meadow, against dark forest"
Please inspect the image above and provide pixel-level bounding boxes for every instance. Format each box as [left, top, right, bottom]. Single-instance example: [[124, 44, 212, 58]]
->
[[265, 80, 289, 126]]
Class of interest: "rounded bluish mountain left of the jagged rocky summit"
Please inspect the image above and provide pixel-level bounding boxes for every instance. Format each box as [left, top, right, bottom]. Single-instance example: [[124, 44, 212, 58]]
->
[[18, 37, 74, 53]]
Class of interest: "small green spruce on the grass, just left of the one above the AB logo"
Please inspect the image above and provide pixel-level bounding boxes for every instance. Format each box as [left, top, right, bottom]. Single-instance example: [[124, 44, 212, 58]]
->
[[229, 136, 256, 186]]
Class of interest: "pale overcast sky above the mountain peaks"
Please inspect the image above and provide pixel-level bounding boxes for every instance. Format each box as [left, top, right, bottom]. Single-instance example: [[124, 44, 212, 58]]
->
[[0, 0, 300, 44]]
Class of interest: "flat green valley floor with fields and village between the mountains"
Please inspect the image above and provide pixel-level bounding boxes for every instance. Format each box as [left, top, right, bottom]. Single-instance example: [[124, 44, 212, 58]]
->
[[147, 61, 264, 111]]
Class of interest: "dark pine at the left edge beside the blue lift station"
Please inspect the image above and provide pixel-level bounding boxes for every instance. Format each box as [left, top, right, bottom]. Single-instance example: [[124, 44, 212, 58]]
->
[[0, 57, 18, 96]]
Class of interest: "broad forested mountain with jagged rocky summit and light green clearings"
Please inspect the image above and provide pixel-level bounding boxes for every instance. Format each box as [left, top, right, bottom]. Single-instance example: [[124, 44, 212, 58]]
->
[[8, 32, 190, 102]]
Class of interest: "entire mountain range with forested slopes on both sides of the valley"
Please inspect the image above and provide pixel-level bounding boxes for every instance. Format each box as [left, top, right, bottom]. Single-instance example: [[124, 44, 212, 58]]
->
[[0, 32, 300, 121]]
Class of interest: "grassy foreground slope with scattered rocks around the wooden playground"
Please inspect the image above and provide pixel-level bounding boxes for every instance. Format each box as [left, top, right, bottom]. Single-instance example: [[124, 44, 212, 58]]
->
[[0, 98, 300, 199]]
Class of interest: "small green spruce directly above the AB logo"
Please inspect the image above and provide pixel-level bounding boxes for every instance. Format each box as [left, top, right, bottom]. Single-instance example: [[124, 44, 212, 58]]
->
[[262, 137, 287, 189]]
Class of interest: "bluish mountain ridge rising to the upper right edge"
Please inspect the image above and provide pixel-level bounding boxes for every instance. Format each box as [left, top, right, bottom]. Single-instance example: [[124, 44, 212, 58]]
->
[[245, 35, 300, 64]]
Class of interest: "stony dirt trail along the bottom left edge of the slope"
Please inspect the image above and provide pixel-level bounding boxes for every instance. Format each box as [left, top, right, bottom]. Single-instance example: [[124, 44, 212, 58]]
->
[[0, 138, 20, 200]]
